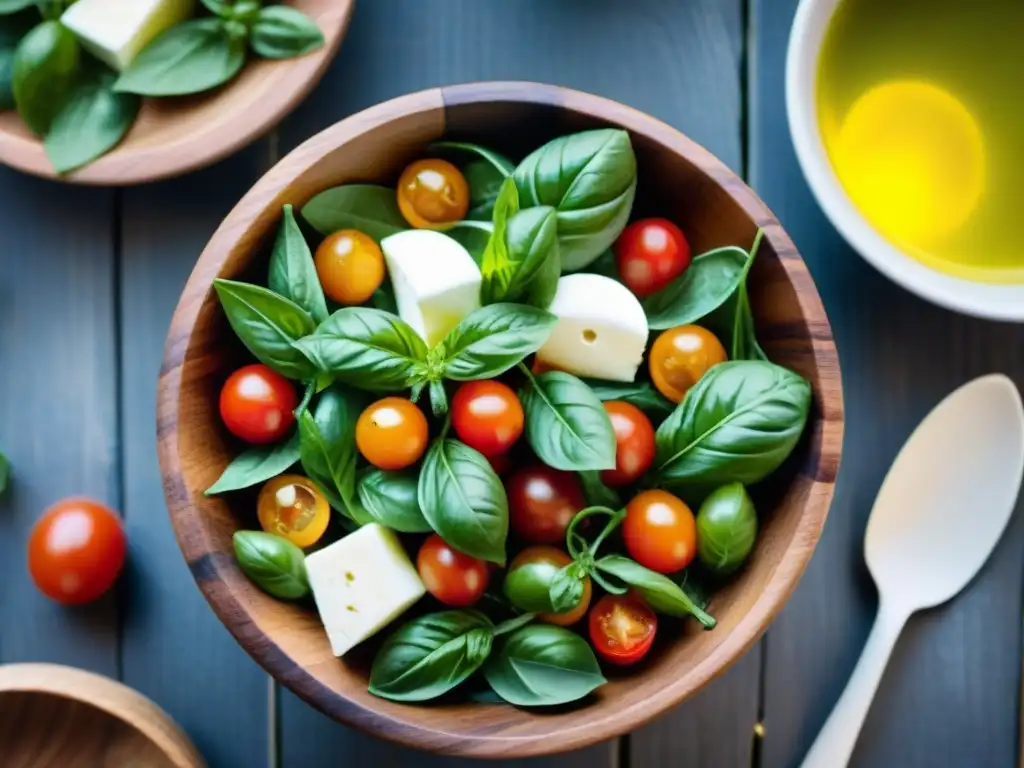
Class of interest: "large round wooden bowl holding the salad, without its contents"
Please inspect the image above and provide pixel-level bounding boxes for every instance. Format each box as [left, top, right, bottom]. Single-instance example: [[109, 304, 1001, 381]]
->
[[158, 83, 843, 757]]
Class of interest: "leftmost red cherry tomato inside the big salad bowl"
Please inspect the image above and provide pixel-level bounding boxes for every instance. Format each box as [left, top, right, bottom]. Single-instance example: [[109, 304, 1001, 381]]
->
[[220, 364, 299, 443]]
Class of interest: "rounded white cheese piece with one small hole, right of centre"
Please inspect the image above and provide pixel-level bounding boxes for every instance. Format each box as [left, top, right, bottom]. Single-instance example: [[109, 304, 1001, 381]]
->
[[537, 273, 647, 381]]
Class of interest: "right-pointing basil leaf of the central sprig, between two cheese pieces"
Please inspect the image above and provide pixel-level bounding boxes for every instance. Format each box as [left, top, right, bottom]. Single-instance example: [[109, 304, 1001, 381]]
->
[[441, 304, 558, 381]]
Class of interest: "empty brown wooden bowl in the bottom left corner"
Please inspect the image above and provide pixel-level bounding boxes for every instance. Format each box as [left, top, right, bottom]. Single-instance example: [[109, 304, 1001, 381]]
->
[[0, 664, 206, 768]]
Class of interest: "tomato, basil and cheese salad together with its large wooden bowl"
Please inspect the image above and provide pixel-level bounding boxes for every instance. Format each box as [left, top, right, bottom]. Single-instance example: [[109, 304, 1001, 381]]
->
[[160, 84, 842, 756]]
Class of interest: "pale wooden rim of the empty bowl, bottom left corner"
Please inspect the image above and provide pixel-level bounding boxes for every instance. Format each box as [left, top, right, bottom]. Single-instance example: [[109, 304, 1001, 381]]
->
[[0, 664, 206, 768]]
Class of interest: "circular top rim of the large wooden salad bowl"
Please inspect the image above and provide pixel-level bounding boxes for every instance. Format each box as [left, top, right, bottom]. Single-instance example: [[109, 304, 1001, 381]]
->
[[158, 81, 844, 758]]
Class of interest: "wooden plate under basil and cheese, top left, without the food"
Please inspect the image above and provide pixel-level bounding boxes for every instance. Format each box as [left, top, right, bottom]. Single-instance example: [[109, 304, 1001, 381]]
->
[[0, 0, 355, 186]]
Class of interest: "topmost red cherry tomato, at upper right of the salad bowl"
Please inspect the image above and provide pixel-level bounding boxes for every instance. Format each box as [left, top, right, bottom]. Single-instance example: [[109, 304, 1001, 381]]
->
[[612, 219, 690, 298]]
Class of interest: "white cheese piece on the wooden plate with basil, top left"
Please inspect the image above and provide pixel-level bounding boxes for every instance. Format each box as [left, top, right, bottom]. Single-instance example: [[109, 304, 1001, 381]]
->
[[60, 0, 196, 72]]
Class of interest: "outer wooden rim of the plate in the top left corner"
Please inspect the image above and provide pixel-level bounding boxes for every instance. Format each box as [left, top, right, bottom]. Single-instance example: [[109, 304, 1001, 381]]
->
[[0, 0, 355, 186]]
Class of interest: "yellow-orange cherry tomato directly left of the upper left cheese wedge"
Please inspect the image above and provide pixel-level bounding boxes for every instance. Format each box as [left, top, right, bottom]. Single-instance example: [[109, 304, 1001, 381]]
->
[[315, 229, 384, 304]]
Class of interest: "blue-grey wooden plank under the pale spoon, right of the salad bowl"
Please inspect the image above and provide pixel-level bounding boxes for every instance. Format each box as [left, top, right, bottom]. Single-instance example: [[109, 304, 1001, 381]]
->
[[751, 0, 1024, 768]]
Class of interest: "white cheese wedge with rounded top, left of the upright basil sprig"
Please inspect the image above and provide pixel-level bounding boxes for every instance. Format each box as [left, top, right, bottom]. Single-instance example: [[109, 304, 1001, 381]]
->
[[381, 229, 482, 347]]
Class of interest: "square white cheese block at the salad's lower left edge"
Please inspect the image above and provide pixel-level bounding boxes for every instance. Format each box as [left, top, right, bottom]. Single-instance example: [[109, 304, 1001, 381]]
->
[[306, 522, 426, 656]]
